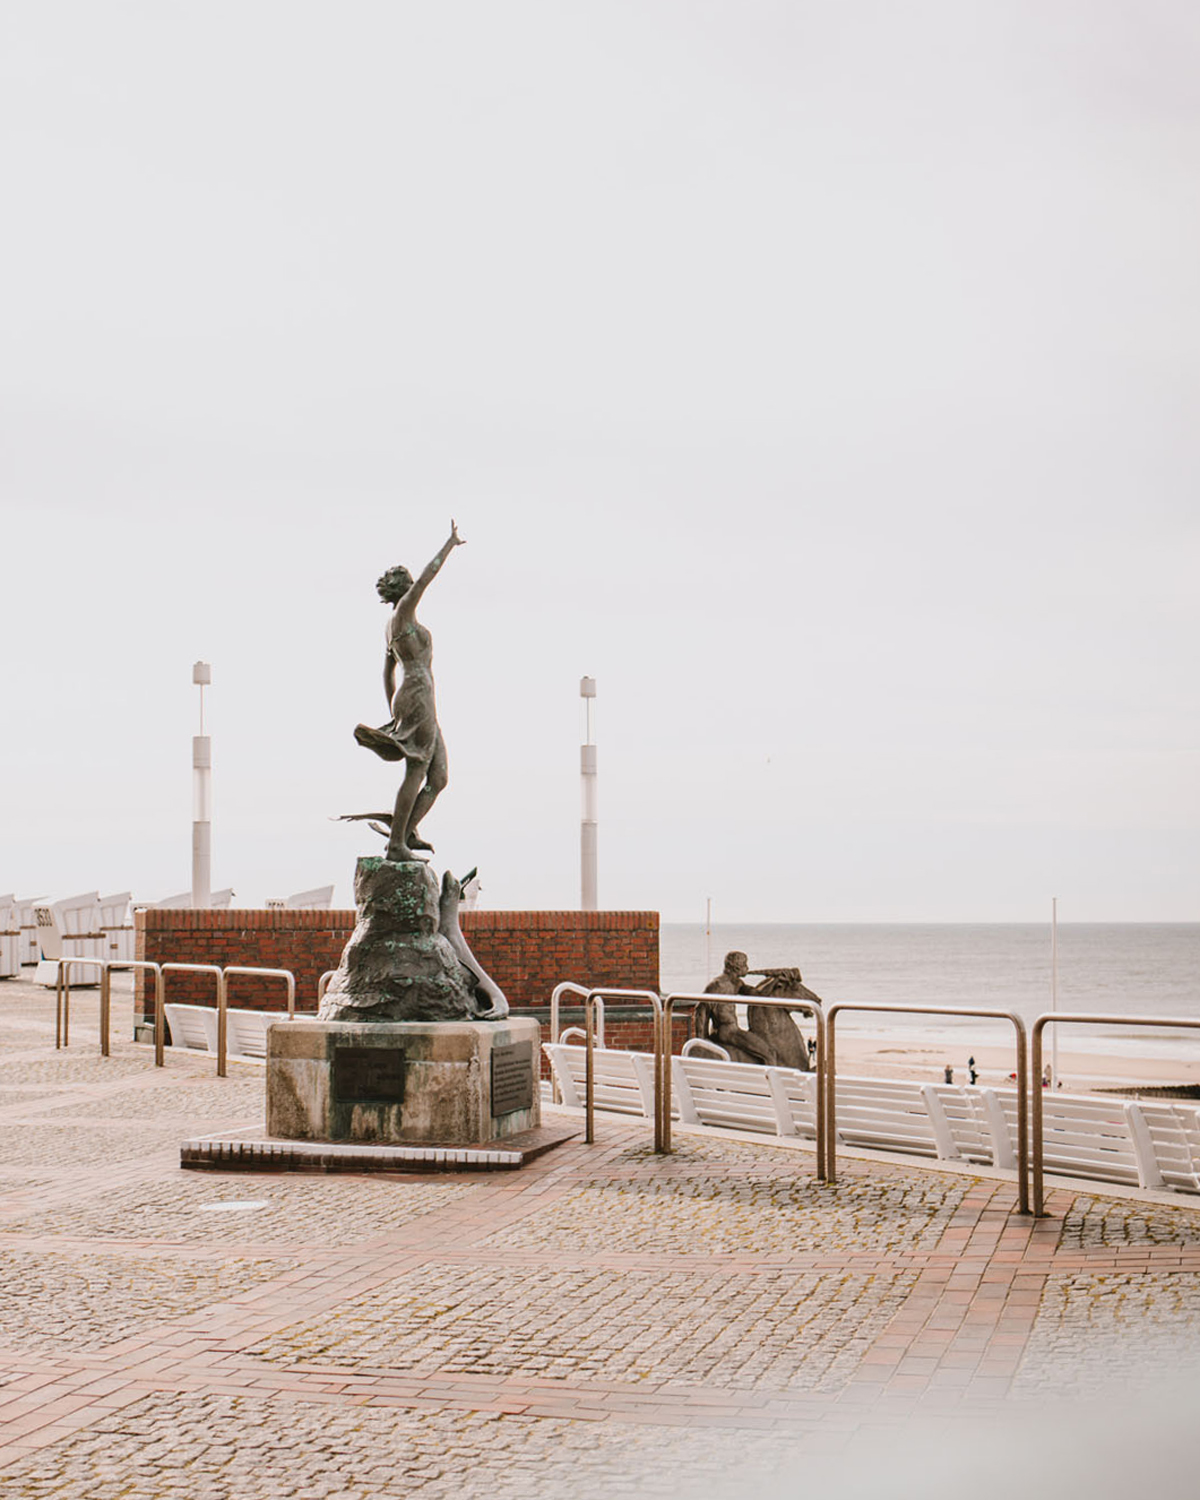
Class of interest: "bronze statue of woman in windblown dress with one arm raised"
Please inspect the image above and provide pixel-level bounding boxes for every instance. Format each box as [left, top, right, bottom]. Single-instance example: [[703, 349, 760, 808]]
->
[[354, 521, 462, 863]]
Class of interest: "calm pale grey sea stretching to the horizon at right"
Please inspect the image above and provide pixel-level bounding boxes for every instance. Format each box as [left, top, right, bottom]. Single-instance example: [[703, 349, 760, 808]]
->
[[660, 923, 1200, 1058]]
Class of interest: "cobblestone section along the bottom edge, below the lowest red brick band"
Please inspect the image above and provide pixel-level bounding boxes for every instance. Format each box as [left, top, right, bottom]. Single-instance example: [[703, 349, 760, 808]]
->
[[0, 1397, 795, 1500]]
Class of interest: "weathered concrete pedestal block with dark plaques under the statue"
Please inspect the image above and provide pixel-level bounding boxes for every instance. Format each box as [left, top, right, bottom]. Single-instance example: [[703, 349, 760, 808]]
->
[[267, 1019, 542, 1146]]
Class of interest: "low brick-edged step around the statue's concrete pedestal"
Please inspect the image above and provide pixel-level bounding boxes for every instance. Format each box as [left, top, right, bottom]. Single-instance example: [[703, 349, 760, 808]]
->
[[179, 1125, 582, 1172]]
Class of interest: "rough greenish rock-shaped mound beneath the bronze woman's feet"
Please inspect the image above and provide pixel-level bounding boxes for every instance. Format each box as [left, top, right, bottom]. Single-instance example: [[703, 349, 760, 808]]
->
[[318, 857, 509, 1022]]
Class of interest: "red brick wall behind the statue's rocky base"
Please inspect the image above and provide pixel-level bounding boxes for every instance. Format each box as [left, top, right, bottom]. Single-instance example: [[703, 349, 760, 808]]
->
[[135, 908, 659, 1046]]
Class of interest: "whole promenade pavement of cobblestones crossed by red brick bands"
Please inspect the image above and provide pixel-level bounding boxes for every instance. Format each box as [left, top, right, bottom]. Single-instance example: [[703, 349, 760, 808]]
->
[[0, 981, 1200, 1500]]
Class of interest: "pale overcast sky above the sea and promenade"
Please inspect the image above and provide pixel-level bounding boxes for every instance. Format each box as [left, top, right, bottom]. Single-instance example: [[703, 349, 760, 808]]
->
[[0, 0, 1200, 921]]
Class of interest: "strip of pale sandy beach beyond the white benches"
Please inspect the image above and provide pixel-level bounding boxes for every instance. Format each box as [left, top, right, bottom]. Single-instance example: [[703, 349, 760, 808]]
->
[[837, 1031, 1200, 1092]]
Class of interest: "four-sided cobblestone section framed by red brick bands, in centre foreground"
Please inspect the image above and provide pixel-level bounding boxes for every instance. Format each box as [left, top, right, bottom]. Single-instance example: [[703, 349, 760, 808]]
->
[[249, 1263, 917, 1391]]
